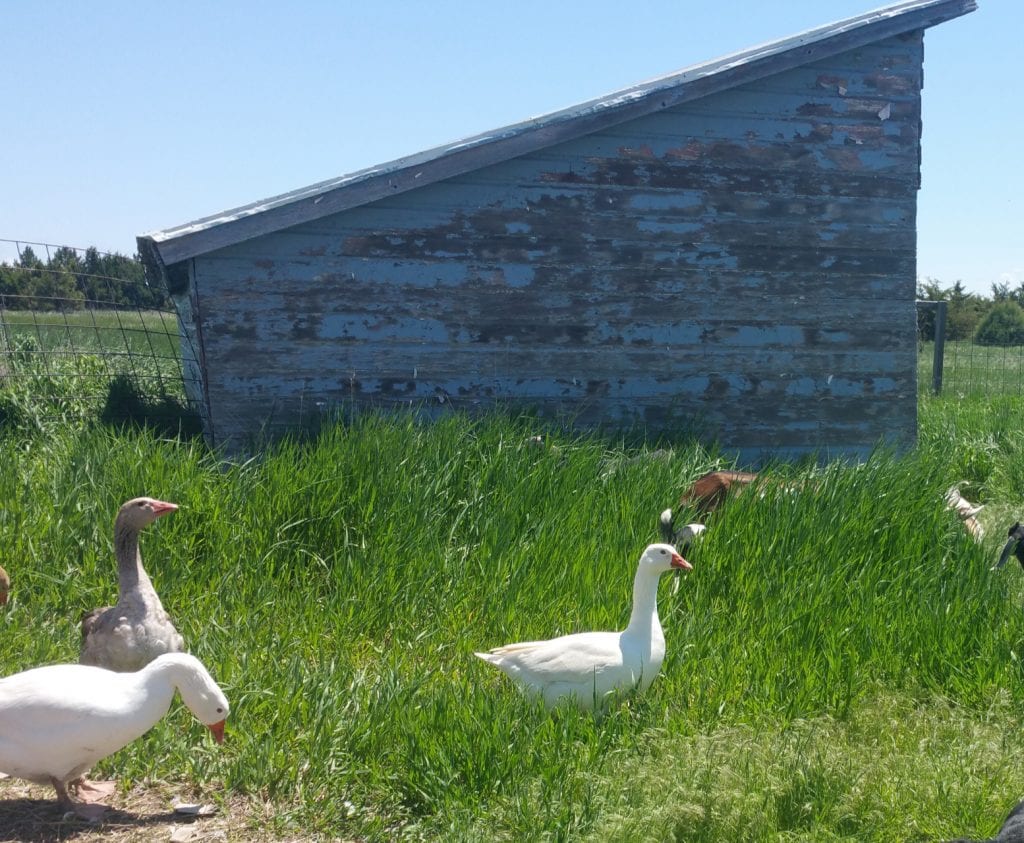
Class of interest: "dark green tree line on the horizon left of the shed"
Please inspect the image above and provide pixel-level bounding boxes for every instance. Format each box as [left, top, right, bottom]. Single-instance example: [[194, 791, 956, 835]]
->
[[0, 246, 171, 310]]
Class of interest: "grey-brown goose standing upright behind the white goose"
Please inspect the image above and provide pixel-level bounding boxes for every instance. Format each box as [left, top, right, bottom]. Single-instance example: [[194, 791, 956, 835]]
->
[[79, 498, 184, 672]]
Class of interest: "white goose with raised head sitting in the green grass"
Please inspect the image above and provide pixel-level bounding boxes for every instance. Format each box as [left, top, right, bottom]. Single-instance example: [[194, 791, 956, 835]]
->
[[476, 544, 692, 710]]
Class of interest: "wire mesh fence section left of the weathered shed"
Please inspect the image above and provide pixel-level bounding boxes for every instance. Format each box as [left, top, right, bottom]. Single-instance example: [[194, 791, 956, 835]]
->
[[0, 240, 201, 432]]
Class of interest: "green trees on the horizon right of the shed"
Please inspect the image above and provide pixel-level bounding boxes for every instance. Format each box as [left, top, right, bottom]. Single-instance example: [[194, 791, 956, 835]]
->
[[918, 279, 1024, 345]]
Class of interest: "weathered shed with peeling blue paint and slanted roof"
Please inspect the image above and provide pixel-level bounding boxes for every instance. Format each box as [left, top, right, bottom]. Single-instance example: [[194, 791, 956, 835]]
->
[[138, 0, 975, 460]]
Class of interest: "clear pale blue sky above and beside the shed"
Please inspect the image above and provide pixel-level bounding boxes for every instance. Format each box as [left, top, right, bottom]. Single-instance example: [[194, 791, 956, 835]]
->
[[0, 0, 1024, 294]]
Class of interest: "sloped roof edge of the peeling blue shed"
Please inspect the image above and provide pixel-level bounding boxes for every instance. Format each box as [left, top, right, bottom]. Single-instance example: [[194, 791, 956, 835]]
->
[[138, 0, 977, 266]]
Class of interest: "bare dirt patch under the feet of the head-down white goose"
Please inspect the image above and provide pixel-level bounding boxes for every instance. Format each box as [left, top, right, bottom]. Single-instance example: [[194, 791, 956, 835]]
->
[[0, 778, 313, 843]]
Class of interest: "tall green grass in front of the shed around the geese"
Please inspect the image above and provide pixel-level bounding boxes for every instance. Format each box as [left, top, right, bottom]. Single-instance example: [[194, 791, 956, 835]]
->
[[6, 329, 1024, 841]]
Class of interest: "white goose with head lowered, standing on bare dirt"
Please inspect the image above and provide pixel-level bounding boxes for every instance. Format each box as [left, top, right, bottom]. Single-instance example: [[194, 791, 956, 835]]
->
[[0, 652, 228, 819]]
